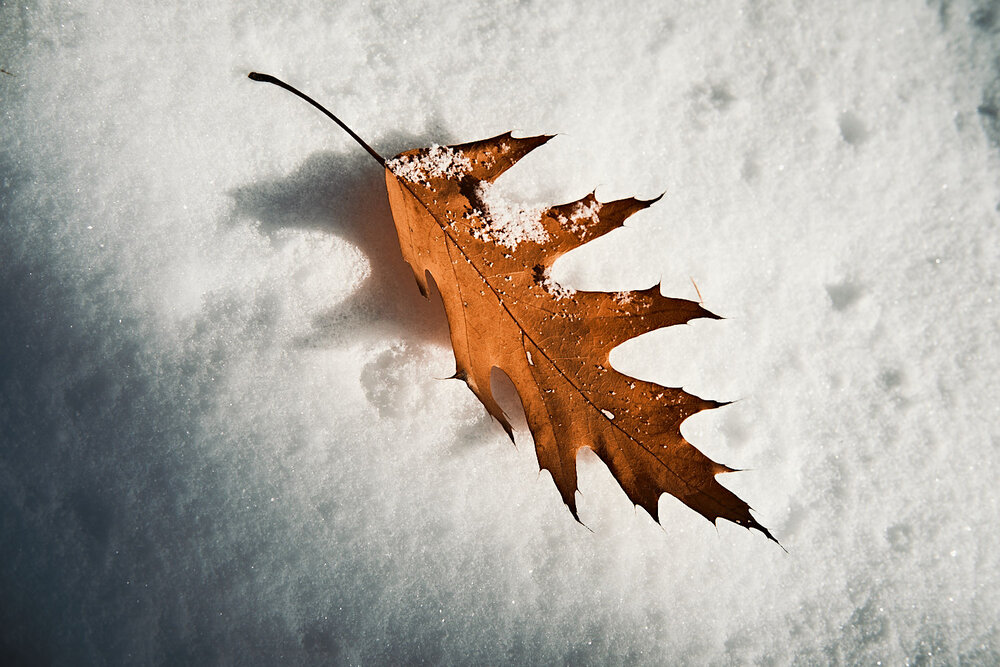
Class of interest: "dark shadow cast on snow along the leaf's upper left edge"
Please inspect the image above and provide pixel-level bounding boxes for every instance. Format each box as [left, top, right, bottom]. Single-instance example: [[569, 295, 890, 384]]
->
[[228, 137, 449, 354]]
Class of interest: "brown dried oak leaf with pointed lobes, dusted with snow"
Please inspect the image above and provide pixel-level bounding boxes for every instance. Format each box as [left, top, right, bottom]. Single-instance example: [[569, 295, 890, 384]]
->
[[251, 75, 774, 540]]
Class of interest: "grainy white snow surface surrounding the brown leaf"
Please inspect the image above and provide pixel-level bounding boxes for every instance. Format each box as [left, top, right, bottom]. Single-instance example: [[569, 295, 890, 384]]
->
[[0, 0, 1000, 665]]
